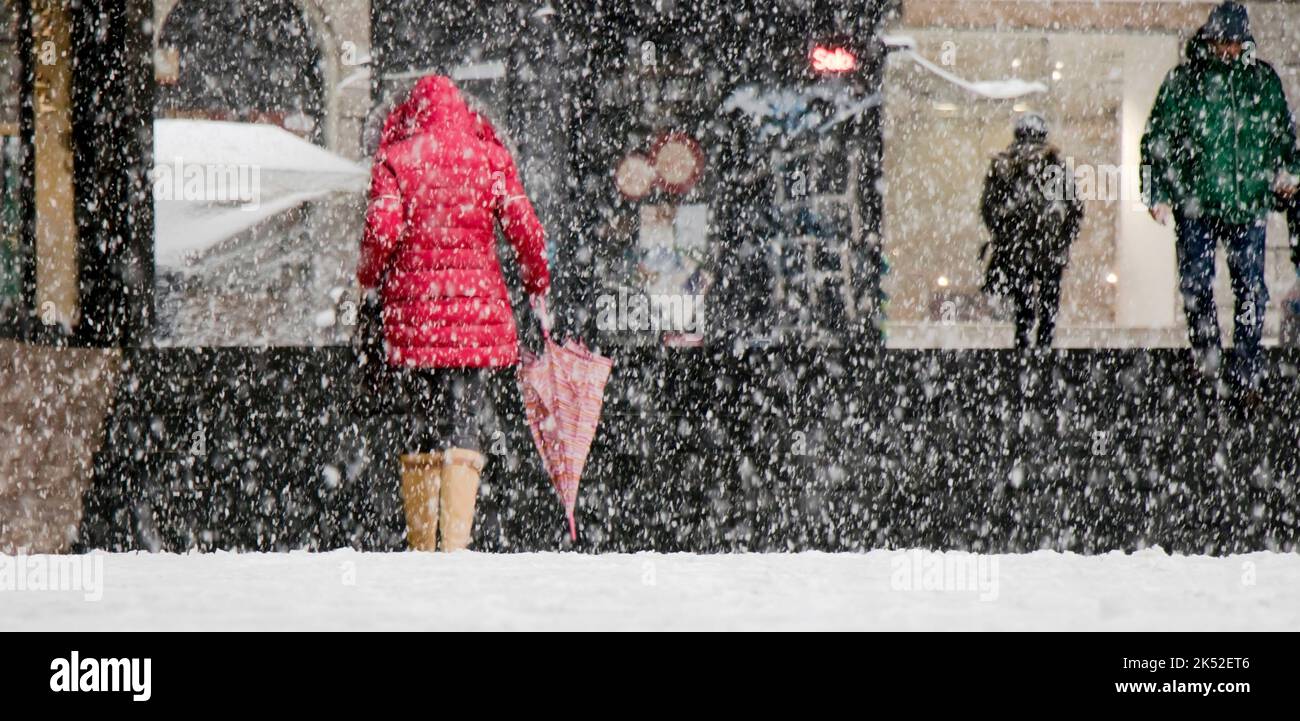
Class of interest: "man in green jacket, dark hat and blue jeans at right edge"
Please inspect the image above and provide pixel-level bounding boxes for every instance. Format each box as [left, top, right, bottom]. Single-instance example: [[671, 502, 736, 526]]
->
[[1141, 3, 1300, 392]]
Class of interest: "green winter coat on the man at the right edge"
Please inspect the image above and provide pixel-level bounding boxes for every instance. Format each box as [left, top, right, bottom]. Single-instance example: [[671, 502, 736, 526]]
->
[[1141, 35, 1300, 225]]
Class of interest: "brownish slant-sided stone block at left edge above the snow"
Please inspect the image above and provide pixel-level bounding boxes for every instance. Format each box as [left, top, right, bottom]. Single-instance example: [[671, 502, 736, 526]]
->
[[0, 340, 120, 553]]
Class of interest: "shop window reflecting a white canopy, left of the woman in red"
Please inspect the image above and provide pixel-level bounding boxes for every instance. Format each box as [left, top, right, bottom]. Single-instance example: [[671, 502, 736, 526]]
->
[[153, 0, 365, 346]]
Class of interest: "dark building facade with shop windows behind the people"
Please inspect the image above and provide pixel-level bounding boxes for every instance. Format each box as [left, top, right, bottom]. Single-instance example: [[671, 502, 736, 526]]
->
[[0, 0, 1300, 552]]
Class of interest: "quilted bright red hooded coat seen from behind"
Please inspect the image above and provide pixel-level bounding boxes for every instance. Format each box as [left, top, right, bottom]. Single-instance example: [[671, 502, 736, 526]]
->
[[358, 75, 550, 368]]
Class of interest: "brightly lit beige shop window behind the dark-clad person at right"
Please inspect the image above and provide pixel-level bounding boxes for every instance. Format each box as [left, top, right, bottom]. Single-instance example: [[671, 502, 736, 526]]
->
[[884, 27, 1294, 348]]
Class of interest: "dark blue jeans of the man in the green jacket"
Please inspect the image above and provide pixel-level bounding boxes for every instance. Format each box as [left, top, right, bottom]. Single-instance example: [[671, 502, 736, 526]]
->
[[1178, 217, 1269, 387]]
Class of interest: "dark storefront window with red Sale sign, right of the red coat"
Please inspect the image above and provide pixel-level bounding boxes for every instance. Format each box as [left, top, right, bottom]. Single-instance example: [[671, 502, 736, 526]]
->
[[374, 1, 884, 347]]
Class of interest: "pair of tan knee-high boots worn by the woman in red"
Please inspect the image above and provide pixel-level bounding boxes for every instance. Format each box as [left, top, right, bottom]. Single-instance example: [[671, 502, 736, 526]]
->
[[402, 448, 486, 551]]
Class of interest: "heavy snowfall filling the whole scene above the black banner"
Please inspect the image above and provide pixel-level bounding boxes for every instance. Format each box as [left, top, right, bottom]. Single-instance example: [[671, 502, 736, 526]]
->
[[0, 0, 1300, 630]]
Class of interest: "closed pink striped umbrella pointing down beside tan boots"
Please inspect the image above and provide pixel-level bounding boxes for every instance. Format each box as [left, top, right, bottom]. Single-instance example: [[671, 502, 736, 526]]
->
[[519, 329, 614, 540]]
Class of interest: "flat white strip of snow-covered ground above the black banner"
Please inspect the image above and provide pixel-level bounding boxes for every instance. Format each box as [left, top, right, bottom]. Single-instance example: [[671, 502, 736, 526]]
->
[[0, 551, 1300, 630]]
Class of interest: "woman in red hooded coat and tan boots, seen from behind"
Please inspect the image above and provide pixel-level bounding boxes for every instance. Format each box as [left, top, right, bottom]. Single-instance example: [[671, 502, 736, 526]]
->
[[358, 75, 550, 551]]
